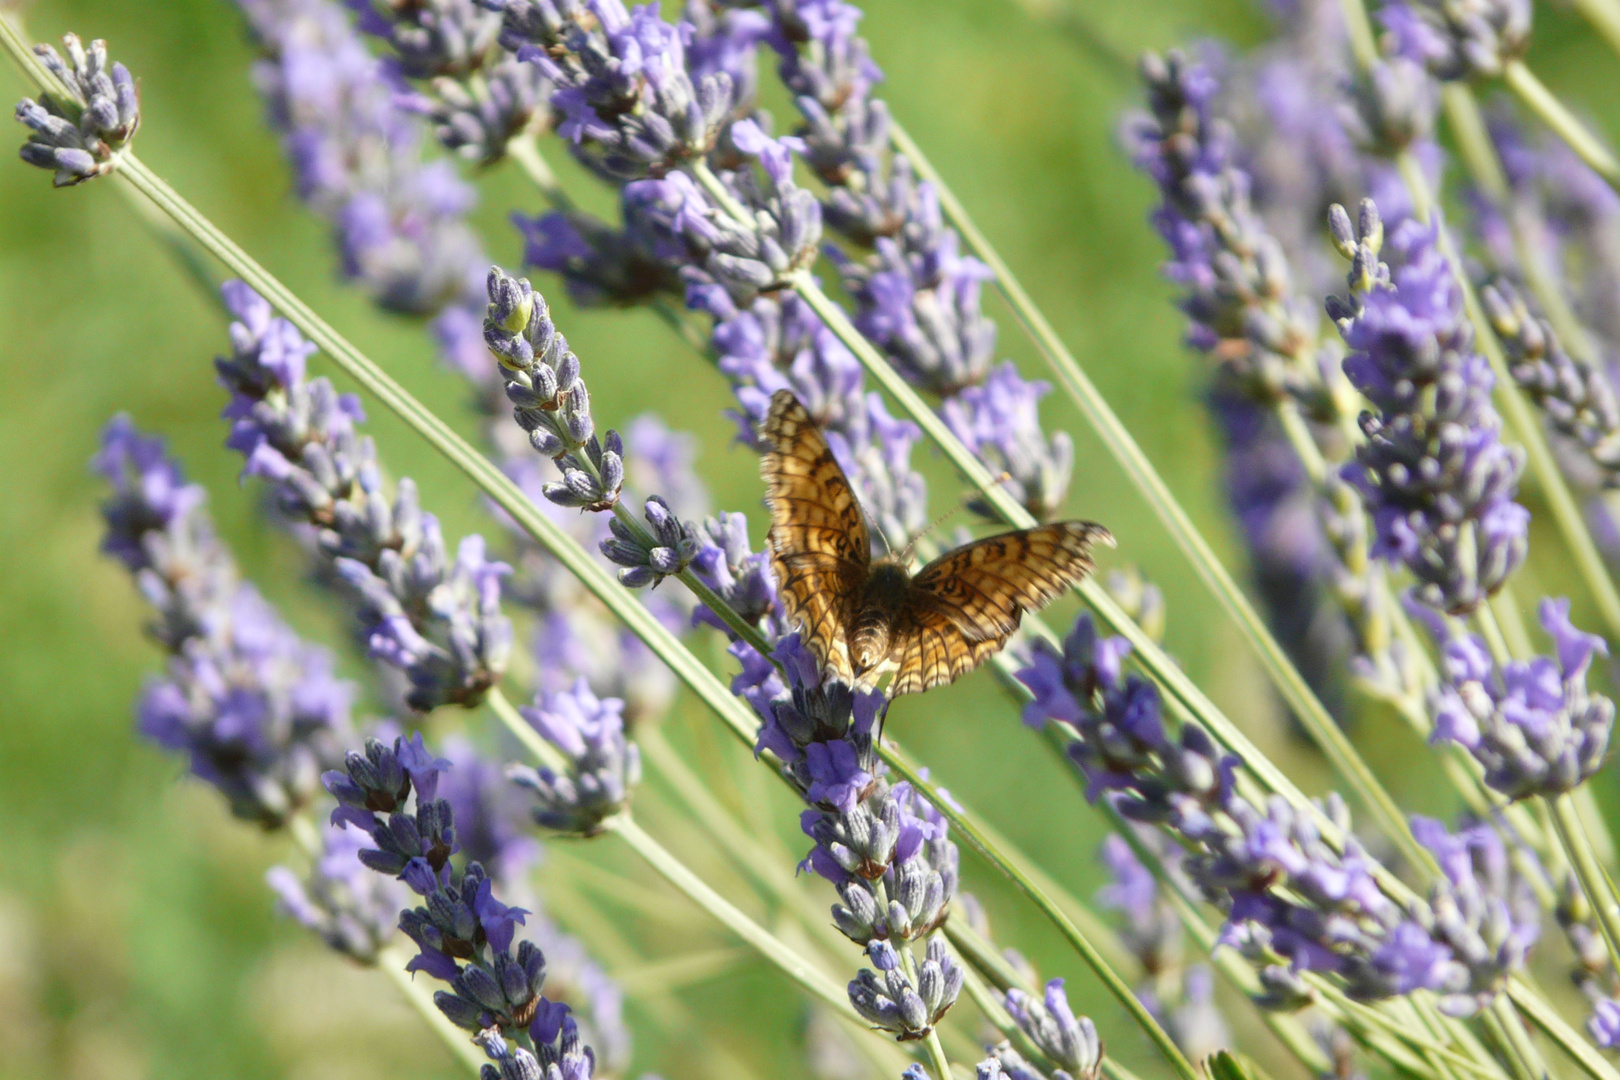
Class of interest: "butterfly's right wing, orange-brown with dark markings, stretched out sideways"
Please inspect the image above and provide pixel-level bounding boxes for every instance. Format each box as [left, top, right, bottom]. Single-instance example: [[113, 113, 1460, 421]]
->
[[889, 521, 1115, 698]]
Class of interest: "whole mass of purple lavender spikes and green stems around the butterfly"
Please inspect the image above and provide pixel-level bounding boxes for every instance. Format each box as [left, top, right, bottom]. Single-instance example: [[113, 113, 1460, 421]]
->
[[15, 0, 1620, 1080]]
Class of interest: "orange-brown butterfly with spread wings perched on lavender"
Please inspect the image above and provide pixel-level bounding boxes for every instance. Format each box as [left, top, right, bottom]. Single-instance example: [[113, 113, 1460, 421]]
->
[[760, 390, 1115, 698]]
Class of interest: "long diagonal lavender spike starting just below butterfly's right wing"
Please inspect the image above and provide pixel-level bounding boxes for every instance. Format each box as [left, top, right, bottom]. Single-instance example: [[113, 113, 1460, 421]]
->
[[1019, 615, 1534, 1015]]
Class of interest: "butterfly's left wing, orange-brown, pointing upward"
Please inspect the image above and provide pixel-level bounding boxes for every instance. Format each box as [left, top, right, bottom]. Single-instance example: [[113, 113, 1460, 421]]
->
[[760, 390, 872, 682]]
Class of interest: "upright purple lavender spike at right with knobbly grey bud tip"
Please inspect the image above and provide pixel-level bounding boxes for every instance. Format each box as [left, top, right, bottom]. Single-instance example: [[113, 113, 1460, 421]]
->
[[1328, 199, 1529, 614]]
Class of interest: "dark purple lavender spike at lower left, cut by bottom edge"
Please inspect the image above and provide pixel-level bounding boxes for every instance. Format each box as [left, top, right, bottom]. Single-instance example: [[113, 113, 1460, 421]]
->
[[322, 735, 595, 1080]]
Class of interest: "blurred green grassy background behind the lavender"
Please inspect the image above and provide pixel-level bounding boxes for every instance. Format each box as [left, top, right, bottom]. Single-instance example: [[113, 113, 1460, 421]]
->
[[0, 0, 1620, 1080]]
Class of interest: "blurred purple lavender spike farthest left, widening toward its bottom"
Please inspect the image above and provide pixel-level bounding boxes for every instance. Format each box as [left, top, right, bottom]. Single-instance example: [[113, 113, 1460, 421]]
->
[[94, 416, 353, 829]]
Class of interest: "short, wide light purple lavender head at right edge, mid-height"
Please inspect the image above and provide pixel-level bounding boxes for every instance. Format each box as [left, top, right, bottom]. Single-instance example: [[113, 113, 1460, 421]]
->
[[1430, 599, 1615, 798]]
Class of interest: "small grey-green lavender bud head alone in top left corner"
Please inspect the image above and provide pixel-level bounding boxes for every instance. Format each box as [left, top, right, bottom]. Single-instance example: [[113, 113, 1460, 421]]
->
[[16, 34, 141, 188]]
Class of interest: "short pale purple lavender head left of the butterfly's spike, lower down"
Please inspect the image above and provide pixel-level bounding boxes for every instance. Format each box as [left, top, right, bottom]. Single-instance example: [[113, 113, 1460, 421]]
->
[[510, 678, 642, 836]]
